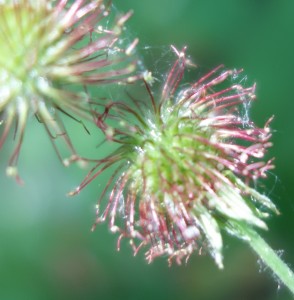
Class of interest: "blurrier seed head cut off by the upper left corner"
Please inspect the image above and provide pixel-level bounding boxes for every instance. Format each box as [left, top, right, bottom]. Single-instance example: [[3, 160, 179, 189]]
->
[[0, 0, 137, 182]]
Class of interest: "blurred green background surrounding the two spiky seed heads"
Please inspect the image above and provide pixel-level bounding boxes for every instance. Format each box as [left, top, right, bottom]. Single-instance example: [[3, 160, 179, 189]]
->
[[0, 0, 294, 300]]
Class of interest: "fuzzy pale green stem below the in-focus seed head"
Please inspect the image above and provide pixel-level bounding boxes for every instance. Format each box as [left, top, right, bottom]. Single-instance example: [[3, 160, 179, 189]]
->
[[238, 225, 294, 294]]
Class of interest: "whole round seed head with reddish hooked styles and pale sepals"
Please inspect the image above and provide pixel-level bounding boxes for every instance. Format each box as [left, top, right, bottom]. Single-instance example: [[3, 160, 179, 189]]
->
[[72, 49, 276, 267]]
